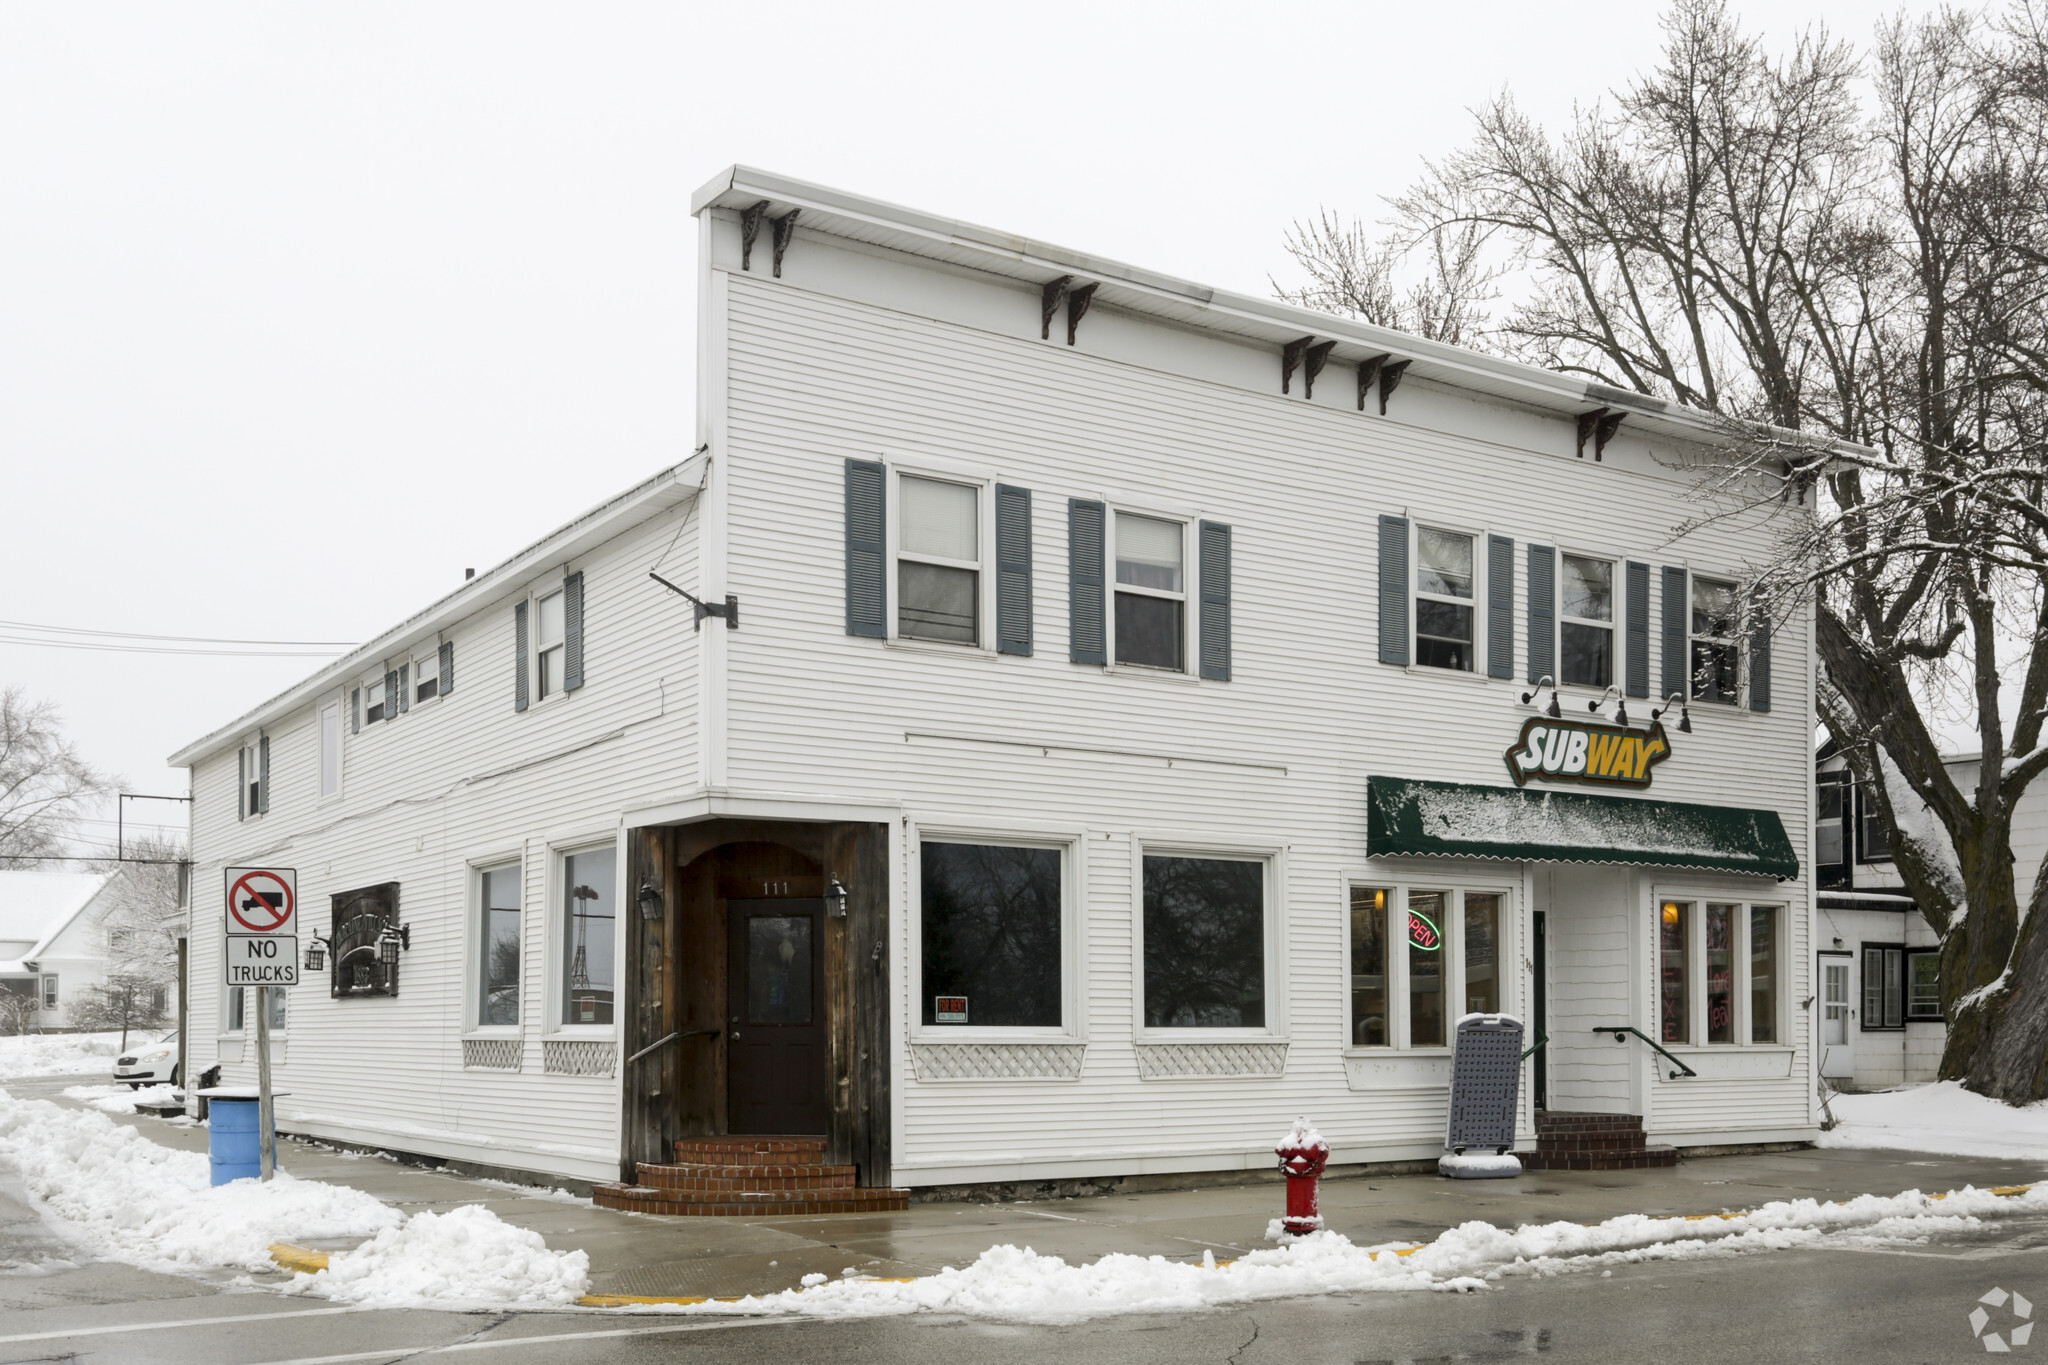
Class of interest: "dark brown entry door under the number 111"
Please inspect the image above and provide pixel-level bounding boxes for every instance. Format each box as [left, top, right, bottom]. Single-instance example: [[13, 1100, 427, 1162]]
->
[[725, 900, 829, 1134]]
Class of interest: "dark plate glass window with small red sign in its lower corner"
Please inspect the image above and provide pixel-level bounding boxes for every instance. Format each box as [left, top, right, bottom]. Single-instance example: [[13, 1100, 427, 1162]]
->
[[918, 839, 1065, 1027]]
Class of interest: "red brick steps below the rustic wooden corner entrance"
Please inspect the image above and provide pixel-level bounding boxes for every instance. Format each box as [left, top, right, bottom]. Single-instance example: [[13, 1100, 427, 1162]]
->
[[590, 1138, 909, 1218]]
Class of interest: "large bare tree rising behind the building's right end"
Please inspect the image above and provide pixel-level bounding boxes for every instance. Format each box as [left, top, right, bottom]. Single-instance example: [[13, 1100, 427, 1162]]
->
[[1288, 0, 2048, 1103]]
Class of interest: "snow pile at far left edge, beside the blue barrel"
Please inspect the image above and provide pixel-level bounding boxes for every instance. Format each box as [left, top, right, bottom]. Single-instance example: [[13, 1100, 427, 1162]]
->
[[0, 1091, 399, 1271]]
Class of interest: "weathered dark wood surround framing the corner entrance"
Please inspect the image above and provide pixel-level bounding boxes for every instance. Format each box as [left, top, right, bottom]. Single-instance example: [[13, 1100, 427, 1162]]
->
[[618, 819, 893, 1187]]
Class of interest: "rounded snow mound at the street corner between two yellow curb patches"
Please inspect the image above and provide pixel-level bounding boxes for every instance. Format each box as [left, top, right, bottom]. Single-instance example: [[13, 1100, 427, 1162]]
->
[[291, 1203, 590, 1308]]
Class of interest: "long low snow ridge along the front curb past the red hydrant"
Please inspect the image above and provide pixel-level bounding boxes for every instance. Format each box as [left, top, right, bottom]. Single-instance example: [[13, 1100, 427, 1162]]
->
[[638, 1187, 2048, 1322]]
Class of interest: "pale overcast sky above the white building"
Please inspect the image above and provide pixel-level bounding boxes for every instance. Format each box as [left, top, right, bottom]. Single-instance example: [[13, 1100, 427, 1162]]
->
[[0, 0, 1923, 855]]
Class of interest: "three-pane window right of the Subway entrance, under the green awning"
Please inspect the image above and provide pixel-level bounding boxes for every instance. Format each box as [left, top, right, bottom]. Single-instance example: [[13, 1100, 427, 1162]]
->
[[1657, 898, 1784, 1046]]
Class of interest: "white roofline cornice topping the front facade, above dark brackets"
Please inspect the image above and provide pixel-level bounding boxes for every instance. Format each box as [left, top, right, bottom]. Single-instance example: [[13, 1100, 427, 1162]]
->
[[690, 166, 1853, 450]]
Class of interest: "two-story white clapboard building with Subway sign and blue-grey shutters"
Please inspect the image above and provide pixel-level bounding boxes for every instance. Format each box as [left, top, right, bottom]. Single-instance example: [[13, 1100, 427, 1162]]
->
[[172, 168, 1815, 1209]]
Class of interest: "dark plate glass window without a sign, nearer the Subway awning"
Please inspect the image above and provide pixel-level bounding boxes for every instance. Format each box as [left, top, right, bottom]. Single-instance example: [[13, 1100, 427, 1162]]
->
[[1145, 853, 1266, 1029]]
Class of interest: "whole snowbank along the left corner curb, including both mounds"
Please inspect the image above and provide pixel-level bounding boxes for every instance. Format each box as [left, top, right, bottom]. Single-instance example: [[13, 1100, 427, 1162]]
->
[[0, 1087, 590, 1308]]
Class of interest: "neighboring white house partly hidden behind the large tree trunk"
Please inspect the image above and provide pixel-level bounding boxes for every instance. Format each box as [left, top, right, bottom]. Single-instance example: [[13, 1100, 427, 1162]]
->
[[1812, 741, 2048, 1091]]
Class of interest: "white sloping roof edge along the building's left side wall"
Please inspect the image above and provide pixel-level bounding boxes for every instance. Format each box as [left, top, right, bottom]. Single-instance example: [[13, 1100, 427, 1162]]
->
[[170, 454, 705, 767]]
